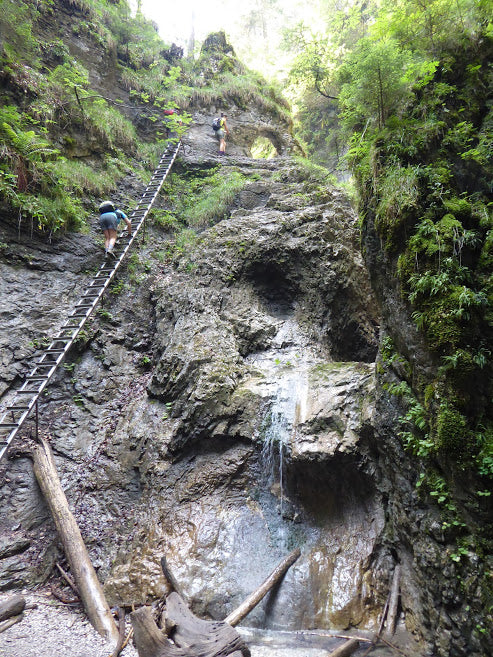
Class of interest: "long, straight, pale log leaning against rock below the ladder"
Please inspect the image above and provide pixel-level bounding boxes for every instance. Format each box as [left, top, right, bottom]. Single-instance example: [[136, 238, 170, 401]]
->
[[33, 439, 119, 647]]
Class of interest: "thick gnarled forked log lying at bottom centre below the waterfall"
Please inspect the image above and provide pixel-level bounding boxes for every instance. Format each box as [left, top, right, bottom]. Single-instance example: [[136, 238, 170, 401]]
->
[[130, 592, 250, 657]]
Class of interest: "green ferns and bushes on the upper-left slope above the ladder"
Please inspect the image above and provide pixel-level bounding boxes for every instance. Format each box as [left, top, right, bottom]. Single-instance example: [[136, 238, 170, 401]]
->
[[0, 0, 189, 234]]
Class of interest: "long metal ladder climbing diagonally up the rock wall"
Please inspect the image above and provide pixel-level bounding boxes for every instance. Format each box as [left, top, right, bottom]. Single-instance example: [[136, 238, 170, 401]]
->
[[0, 142, 181, 460]]
